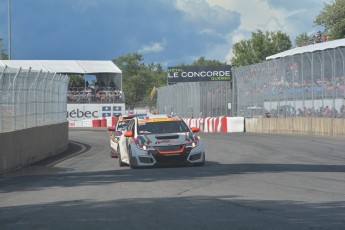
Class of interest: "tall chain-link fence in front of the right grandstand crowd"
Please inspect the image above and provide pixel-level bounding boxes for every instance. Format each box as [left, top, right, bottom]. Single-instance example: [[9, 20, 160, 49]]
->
[[233, 47, 345, 118]]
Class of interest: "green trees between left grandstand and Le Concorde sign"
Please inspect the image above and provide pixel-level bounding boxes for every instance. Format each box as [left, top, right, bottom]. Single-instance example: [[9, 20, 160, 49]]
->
[[113, 53, 167, 106]]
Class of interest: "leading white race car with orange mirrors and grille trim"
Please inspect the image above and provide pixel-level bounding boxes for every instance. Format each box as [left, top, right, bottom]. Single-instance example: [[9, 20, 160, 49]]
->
[[118, 115, 205, 168]]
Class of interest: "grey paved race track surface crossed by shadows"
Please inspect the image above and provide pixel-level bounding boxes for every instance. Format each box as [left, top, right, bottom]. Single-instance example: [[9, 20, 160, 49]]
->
[[0, 130, 345, 230]]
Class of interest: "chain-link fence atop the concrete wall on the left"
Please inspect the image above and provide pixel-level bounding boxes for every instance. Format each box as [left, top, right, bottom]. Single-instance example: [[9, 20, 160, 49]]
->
[[0, 67, 69, 133]]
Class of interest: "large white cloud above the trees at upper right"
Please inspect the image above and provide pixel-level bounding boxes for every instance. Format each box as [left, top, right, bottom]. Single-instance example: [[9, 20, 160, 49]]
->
[[206, 0, 323, 62]]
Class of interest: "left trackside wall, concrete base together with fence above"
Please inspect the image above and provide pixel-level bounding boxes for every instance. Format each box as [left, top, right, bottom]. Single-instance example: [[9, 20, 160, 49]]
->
[[0, 66, 69, 173]]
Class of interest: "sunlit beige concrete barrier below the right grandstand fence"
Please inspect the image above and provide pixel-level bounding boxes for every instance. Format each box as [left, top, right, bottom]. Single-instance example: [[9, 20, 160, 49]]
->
[[245, 117, 345, 136]]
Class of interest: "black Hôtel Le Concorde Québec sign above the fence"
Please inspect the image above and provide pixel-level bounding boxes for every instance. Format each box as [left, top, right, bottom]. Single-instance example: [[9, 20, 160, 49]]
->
[[168, 65, 231, 84]]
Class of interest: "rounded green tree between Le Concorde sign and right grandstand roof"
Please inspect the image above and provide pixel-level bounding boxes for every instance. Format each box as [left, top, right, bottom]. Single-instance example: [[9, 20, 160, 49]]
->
[[231, 30, 292, 67]]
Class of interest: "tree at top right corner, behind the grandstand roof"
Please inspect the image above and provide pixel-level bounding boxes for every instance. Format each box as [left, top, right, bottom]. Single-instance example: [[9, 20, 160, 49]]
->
[[314, 0, 345, 40]]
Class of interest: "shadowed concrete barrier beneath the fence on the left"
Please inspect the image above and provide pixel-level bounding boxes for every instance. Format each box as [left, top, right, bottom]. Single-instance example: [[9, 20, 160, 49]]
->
[[0, 122, 68, 173]]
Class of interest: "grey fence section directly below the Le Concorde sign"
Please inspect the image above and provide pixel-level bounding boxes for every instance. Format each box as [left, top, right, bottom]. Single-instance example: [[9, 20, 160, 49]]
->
[[157, 81, 232, 117]]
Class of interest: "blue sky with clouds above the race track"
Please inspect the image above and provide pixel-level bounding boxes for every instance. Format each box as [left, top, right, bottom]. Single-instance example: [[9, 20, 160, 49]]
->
[[0, 0, 330, 67]]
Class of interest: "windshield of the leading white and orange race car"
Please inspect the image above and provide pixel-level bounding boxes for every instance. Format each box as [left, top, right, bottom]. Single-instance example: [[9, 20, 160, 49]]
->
[[138, 120, 189, 134]]
